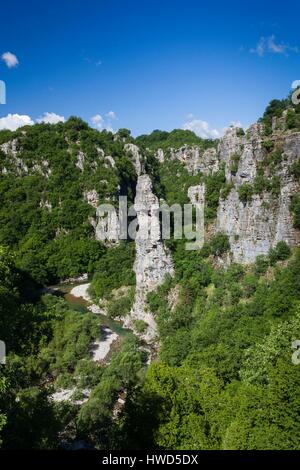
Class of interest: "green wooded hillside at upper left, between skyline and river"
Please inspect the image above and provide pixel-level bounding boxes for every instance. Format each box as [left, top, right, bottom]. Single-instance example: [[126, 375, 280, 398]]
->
[[0, 118, 136, 284]]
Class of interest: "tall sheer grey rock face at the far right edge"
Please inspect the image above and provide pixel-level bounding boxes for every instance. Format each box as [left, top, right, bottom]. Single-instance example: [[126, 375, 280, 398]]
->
[[216, 129, 300, 263]]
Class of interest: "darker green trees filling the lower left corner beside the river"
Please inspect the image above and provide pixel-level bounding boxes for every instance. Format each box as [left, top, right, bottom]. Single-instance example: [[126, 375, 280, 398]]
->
[[0, 248, 145, 448]]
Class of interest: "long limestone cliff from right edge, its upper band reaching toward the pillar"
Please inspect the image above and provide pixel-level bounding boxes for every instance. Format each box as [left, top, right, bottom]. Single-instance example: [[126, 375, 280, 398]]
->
[[162, 123, 300, 263]]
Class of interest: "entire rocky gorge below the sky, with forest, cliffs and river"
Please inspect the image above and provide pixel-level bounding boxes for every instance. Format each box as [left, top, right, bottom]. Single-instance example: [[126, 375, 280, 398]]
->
[[0, 91, 300, 449]]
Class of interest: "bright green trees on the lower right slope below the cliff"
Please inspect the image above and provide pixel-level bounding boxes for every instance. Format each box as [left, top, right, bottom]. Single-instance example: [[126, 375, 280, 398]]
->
[[123, 243, 300, 450]]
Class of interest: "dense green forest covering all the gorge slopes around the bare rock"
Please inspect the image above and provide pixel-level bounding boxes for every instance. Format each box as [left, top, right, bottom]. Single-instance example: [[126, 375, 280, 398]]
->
[[0, 91, 300, 450]]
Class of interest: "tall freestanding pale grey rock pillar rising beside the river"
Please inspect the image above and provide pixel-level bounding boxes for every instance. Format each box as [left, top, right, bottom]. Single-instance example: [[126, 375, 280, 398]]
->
[[125, 174, 174, 340]]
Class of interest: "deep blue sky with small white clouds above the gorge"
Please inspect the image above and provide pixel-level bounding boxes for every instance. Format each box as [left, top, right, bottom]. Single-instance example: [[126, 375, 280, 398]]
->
[[0, 0, 300, 136]]
